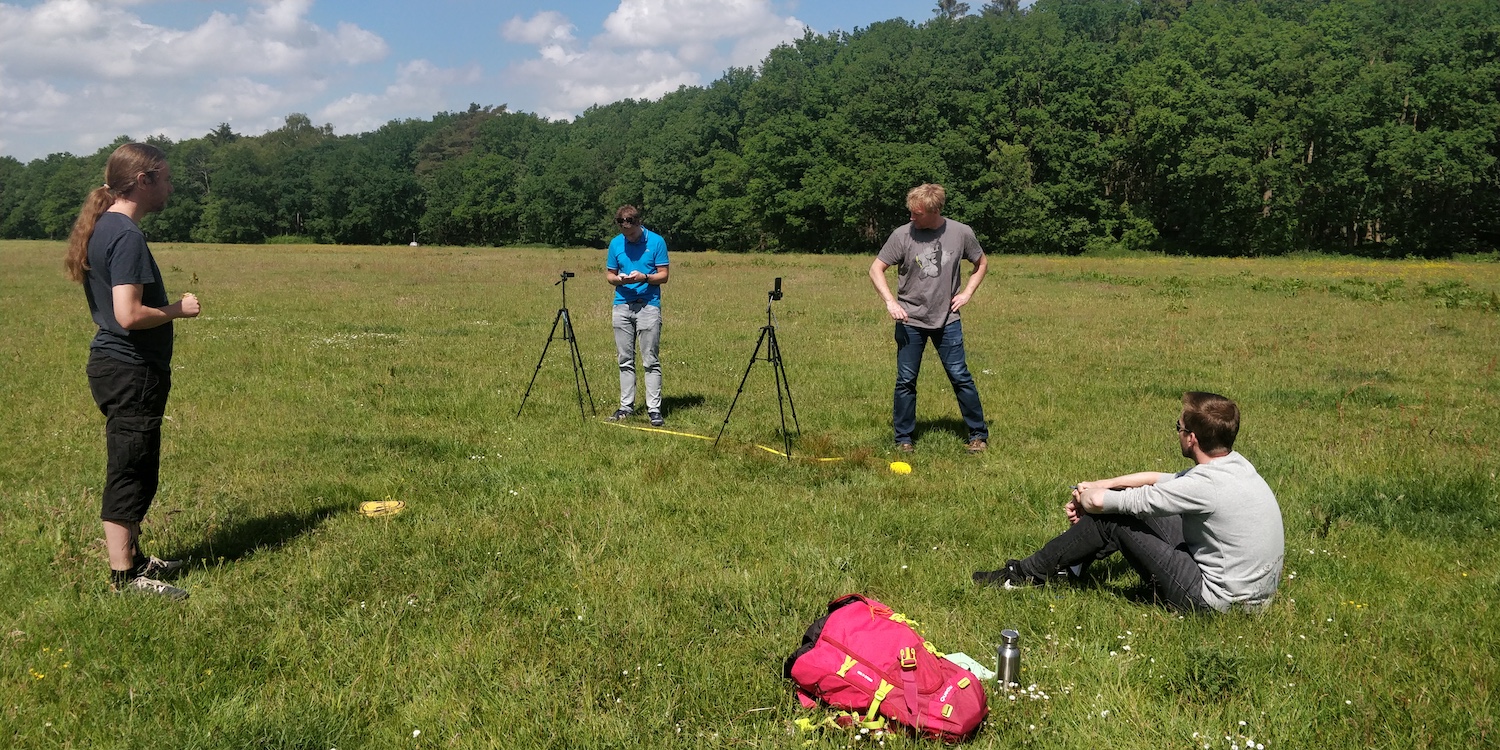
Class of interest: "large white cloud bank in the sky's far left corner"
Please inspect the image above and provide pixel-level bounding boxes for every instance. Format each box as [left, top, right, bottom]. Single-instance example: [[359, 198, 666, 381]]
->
[[0, 0, 405, 159]]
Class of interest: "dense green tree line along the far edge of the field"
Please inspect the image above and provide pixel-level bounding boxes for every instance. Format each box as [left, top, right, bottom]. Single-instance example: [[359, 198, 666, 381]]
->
[[0, 0, 1500, 257]]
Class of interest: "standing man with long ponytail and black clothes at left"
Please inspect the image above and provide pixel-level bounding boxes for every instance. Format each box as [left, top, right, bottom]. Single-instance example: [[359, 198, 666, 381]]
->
[[63, 143, 200, 599]]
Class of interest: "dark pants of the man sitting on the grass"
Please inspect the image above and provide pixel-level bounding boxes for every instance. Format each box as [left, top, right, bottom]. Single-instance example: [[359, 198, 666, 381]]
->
[[1017, 513, 1209, 611]]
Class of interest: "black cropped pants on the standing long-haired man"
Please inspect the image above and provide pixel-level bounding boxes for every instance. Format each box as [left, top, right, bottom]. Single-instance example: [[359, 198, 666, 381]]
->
[[87, 353, 173, 524]]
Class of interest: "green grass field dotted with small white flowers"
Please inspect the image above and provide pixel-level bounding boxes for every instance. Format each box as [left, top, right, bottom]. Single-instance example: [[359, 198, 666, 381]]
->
[[0, 243, 1500, 750]]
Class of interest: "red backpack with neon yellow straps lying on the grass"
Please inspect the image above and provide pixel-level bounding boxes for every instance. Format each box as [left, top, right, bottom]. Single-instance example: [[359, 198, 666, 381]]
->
[[785, 594, 990, 743]]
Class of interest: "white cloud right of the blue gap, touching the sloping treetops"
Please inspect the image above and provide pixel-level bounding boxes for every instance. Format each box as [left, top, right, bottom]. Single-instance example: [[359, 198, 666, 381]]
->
[[501, 0, 806, 117]]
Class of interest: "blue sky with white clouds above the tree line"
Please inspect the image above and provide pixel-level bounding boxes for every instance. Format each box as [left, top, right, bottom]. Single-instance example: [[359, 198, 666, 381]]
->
[[0, 0, 1008, 162]]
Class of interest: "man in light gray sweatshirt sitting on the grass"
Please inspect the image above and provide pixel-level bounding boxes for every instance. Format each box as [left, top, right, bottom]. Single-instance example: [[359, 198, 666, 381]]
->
[[974, 392, 1284, 612]]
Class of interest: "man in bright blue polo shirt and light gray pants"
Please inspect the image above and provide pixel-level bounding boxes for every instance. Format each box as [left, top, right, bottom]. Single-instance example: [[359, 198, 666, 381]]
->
[[605, 204, 668, 428]]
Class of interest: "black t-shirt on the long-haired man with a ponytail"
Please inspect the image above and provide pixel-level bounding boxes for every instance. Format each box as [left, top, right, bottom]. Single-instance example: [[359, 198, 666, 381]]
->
[[84, 212, 173, 371]]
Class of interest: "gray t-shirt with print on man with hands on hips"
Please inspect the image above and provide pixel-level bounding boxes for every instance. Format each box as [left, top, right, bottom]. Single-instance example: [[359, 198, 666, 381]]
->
[[879, 219, 984, 329]]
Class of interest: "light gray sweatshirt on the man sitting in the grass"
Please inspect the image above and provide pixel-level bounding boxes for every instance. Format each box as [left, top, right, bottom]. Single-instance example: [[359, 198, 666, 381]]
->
[[1104, 452, 1286, 612]]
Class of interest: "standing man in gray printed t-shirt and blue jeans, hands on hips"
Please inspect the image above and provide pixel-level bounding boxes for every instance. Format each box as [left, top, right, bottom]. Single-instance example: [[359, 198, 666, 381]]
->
[[870, 185, 990, 453]]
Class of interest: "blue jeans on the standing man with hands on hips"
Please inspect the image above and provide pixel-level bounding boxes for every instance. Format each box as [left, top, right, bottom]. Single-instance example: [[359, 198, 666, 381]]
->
[[891, 321, 990, 444]]
